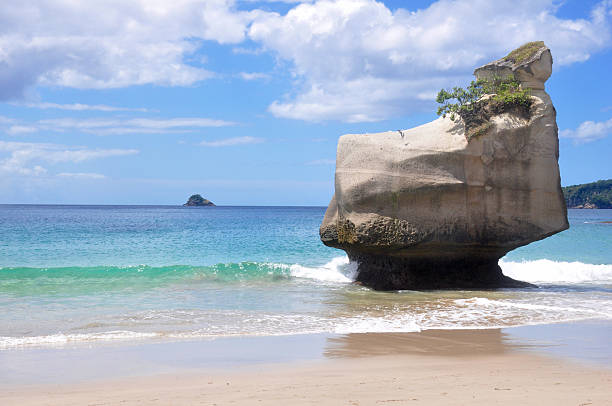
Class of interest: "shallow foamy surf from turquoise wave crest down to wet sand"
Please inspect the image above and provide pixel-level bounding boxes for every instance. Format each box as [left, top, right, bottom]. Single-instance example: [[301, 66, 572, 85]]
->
[[0, 256, 612, 349]]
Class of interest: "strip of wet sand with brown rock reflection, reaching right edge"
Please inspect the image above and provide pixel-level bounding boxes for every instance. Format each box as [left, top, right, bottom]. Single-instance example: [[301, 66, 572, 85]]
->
[[323, 320, 612, 368]]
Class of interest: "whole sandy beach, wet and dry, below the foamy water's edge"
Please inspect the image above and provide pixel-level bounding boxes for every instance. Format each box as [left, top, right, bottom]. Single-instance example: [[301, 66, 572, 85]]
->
[[0, 321, 612, 405]]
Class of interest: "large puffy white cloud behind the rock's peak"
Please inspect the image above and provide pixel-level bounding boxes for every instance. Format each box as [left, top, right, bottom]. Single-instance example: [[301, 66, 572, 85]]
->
[[249, 0, 611, 122]]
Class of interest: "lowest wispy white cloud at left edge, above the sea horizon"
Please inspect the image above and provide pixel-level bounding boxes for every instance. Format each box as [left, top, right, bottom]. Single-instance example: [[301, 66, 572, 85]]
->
[[0, 141, 139, 176]]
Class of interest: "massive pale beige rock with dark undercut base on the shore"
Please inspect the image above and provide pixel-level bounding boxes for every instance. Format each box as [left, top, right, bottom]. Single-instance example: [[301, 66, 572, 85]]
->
[[320, 43, 568, 290]]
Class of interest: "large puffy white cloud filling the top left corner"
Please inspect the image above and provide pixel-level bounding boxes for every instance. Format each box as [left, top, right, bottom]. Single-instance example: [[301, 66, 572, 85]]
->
[[0, 0, 259, 100]]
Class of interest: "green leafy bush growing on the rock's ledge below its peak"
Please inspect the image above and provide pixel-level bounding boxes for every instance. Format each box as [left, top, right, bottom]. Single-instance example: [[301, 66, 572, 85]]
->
[[436, 75, 531, 140]]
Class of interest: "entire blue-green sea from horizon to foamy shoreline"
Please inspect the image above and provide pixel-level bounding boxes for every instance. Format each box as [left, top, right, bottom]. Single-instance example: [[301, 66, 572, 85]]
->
[[0, 205, 612, 350]]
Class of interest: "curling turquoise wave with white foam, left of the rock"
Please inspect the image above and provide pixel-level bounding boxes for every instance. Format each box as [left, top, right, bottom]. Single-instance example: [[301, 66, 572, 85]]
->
[[0, 256, 356, 295]]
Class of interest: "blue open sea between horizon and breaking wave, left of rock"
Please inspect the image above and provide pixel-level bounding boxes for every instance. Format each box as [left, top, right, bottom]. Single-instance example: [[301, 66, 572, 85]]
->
[[0, 206, 337, 268]]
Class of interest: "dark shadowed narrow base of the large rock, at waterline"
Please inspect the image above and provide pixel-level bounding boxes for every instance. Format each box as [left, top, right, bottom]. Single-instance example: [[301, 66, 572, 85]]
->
[[348, 253, 535, 290]]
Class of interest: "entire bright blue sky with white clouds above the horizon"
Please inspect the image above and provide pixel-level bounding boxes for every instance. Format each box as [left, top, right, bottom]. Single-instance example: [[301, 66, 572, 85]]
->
[[0, 0, 612, 206]]
